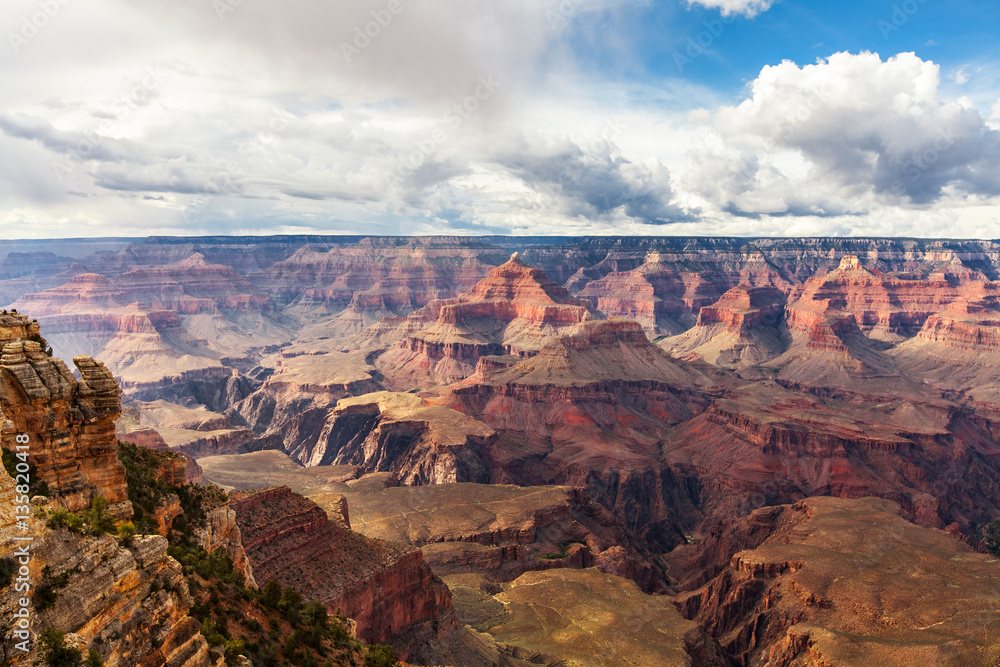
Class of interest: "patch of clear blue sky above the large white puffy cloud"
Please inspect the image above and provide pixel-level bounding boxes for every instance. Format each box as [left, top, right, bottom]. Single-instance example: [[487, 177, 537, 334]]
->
[[576, 0, 1000, 101]]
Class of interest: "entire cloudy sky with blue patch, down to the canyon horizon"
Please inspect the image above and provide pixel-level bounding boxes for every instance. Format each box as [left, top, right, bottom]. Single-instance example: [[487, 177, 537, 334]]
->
[[0, 0, 1000, 239]]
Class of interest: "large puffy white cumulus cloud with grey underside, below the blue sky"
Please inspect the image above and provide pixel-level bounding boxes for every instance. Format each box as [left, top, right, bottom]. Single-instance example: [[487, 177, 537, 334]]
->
[[684, 53, 1000, 215]]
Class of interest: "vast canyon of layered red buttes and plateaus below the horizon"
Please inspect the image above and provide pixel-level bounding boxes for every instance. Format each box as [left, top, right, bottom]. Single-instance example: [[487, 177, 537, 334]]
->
[[0, 236, 1000, 667]]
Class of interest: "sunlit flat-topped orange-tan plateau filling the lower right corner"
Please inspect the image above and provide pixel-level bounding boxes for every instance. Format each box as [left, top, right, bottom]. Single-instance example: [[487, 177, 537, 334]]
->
[[678, 498, 1000, 667]]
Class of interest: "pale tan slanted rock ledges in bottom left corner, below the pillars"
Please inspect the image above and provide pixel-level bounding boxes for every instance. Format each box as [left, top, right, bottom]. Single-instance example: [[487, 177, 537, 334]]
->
[[0, 460, 223, 667]]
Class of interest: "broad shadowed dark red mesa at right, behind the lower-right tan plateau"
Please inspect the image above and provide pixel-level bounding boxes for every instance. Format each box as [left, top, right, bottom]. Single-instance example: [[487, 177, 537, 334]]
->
[[663, 382, 1000, 531]]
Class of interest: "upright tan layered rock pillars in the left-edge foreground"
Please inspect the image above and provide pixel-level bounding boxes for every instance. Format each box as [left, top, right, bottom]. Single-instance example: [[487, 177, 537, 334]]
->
[[0, 315, 132, 518]]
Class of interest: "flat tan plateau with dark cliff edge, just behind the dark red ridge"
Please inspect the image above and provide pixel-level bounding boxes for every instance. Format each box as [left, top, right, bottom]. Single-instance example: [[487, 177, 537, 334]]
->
[[332, 478, 664, 592]]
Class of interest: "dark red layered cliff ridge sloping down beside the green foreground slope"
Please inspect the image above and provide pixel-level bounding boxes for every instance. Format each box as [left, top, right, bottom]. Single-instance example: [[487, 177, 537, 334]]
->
[[230, 487, 454, 653]]
